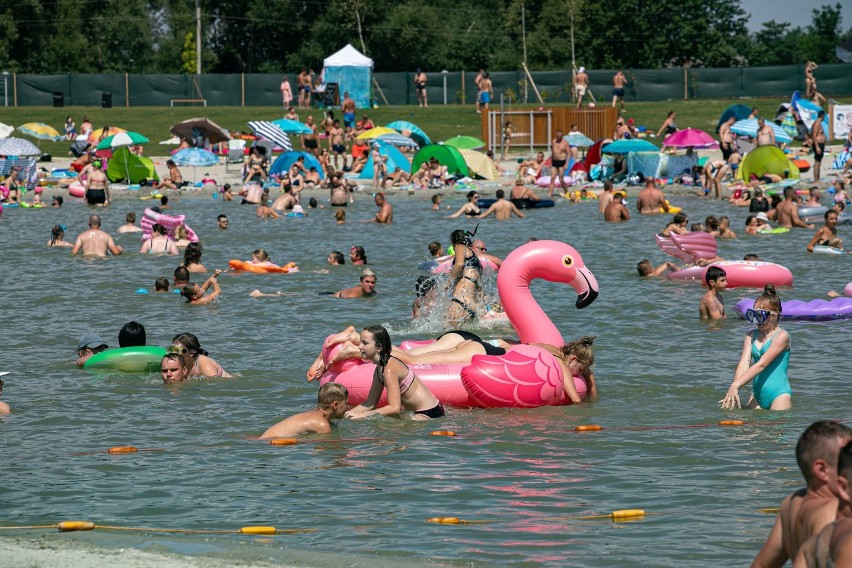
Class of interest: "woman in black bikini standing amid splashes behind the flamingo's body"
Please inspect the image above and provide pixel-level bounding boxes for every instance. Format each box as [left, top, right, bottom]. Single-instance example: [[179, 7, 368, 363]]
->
[[445, 229, 482, 327]]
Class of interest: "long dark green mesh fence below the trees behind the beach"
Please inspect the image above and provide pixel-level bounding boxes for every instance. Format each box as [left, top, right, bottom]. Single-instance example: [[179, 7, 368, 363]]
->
[[4, 64, 852, 106]]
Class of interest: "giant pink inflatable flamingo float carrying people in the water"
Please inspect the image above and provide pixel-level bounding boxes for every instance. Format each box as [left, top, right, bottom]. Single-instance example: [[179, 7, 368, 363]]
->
[[320, 241, 598, 408]]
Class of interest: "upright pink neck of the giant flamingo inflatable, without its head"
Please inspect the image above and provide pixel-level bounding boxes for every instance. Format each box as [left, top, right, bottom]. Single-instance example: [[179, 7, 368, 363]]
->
[[497, 253, 564, 346]]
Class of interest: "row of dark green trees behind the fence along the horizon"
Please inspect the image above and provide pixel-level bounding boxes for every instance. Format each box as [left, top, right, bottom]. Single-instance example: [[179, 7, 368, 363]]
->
[[0, 0, 852, 74]]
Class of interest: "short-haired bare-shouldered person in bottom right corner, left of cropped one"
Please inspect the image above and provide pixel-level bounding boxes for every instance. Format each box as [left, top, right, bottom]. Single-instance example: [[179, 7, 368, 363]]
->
[[752, 421, 852, 567]]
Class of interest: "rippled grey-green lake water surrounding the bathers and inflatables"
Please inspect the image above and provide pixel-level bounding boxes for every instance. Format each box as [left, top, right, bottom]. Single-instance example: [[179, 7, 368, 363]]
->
[[0, 190, 852, 566]]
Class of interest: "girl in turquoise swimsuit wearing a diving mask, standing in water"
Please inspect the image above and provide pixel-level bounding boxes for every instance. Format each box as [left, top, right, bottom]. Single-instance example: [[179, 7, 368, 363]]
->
[[719, 284, 793, 410]]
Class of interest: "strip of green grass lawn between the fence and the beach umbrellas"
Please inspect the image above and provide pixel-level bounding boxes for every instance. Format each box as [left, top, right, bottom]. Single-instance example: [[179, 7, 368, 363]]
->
[[0, 99, 784, 156]]
